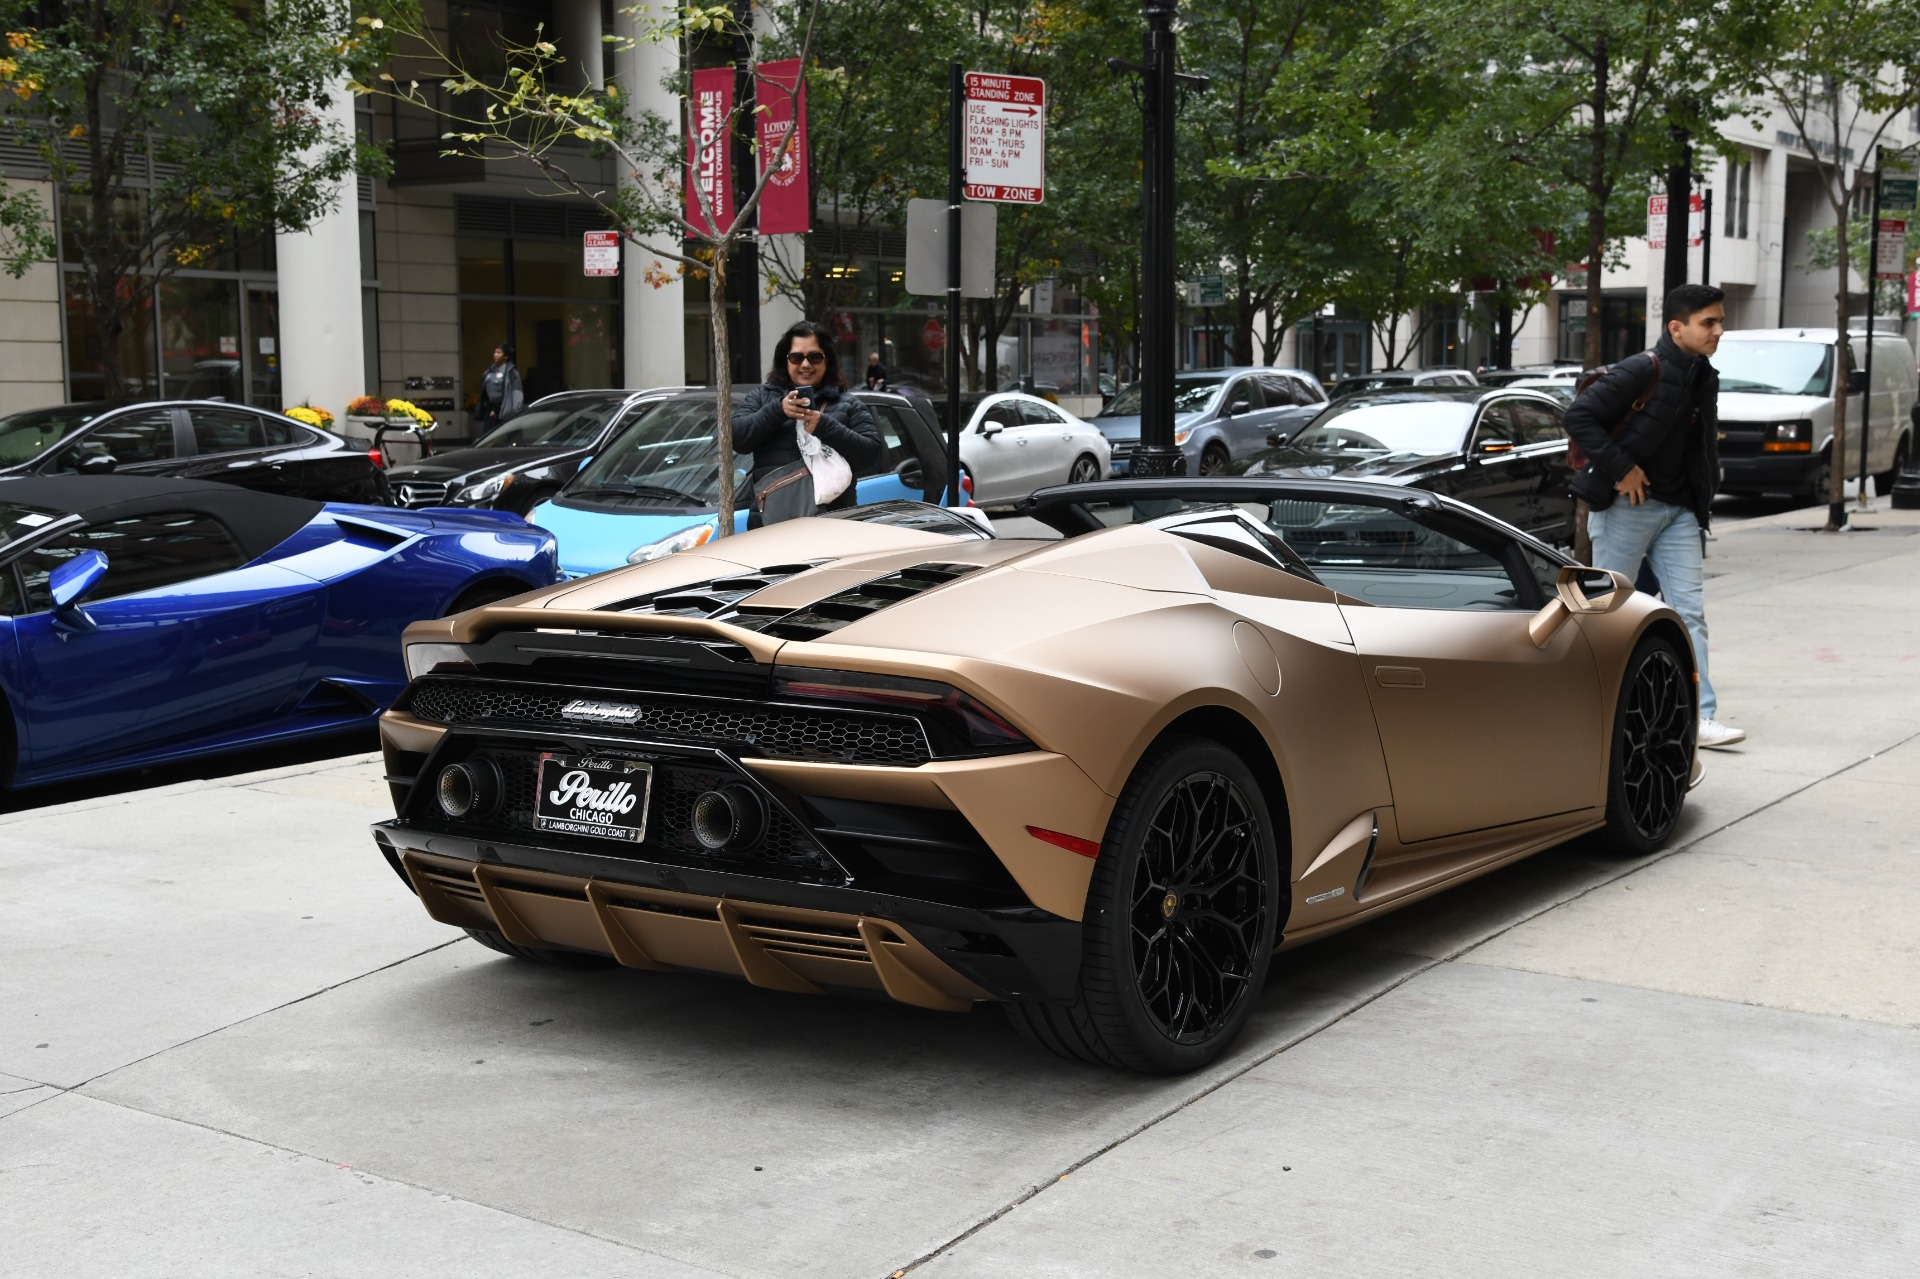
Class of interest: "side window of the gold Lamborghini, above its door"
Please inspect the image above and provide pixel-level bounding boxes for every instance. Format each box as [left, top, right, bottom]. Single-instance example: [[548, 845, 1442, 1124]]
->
[[1267, 499, 1532, 611]]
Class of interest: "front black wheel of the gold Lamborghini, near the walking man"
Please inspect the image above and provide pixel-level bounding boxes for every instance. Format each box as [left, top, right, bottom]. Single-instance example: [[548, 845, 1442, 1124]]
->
[[1607, 636, 1699, 855]]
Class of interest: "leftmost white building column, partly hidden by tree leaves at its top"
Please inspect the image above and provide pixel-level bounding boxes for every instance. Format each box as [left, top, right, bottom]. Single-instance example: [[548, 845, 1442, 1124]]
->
[[275, 88, 374, 417]]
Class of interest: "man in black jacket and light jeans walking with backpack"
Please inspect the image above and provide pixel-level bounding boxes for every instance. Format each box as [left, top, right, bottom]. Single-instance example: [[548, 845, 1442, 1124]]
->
[[1567, 284, 1747, 749]]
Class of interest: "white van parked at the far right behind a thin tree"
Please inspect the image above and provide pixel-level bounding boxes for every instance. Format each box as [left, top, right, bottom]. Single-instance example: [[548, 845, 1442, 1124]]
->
[[1713, 328, 1916, 501]]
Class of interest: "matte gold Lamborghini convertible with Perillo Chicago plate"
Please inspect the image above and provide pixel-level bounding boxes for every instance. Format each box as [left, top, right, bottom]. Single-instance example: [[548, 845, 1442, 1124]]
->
[[374, 478, 1699, 1072]]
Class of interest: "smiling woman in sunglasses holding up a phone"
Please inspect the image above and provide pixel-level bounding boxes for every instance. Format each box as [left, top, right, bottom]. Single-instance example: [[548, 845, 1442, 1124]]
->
[[733, 321, 887, 528]]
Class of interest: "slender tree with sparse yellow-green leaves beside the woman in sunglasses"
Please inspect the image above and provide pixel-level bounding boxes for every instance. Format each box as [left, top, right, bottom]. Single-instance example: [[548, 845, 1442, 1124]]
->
[[370, 0, 820, 538]]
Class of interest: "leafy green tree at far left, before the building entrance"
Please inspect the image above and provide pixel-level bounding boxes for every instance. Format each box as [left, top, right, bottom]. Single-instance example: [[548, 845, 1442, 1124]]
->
[[0, 0, 386, 394]]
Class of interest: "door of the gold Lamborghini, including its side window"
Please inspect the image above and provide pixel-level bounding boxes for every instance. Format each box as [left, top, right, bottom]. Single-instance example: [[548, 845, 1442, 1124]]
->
[[1275, 499, 1605, 843]]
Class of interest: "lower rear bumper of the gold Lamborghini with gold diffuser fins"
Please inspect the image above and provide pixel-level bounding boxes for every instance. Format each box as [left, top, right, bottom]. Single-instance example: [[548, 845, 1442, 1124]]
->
[[372, 820, 1081, 1012]]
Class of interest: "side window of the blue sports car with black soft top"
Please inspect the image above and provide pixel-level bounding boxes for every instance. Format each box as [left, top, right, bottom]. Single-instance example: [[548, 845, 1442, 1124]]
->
[[15, 511, 246, 613]]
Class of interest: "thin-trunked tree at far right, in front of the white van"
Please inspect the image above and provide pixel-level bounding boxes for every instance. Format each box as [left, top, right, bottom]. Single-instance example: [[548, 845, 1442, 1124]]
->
[[1720, 0, 1920, 530]]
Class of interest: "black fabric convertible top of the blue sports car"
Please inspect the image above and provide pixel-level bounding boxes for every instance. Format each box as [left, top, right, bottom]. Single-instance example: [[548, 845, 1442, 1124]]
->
[[0, 474, 323, 559]]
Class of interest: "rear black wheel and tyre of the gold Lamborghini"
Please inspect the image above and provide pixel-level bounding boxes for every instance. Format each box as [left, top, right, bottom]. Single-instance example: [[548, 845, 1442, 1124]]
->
[[1008, 737, 1284, 1074]]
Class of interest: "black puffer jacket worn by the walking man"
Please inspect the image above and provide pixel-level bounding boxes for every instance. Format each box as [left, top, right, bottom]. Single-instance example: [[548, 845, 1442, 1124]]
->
[[1567, 334, 1720, 528]]
